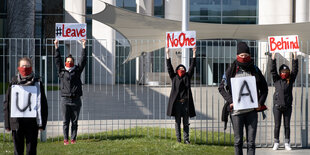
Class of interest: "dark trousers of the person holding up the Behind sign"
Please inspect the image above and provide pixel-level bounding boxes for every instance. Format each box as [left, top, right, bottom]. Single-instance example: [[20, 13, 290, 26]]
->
[[273, 106, 292, 143]]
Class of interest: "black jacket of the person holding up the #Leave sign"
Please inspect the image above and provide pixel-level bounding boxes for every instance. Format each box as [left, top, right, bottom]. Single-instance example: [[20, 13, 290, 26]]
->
[[55, 48, 87, 97]]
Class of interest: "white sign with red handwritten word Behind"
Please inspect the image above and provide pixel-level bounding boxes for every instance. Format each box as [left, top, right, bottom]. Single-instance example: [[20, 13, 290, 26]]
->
[[268, 35, 299, 53]]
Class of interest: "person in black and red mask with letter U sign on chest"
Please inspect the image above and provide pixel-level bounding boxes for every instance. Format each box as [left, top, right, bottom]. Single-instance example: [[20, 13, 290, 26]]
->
[[3, 57, 48, 155]]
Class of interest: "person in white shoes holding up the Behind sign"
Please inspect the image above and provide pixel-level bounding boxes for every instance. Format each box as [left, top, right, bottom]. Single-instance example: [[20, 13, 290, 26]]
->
[[271, 52, 298, 150]]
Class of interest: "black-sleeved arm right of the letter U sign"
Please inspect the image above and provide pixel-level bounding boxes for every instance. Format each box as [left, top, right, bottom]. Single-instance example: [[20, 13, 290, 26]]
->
[[39, 82, 48, 130]]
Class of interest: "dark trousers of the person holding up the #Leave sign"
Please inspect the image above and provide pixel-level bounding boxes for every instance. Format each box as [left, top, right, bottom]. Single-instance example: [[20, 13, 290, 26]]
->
[[62, 97, 82, 140]]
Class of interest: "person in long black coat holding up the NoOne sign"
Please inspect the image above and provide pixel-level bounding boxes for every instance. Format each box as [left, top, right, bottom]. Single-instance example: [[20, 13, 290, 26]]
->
[[166, 47, 196, 144]]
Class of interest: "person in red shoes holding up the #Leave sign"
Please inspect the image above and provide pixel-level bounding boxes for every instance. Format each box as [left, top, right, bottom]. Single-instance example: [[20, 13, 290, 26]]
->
[[54, 39, 87, 145]]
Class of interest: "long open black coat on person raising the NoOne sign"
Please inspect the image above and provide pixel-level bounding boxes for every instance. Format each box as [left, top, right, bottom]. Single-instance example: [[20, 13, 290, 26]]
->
[[167, 58, 196, 117]]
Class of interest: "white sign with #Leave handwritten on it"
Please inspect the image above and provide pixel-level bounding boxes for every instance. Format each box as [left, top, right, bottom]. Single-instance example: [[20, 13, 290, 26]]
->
[[55, 23, 86, 40]]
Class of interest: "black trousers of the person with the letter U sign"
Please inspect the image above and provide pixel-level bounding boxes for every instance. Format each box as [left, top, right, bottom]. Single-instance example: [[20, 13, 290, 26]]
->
[[12, 118, 38, 155]]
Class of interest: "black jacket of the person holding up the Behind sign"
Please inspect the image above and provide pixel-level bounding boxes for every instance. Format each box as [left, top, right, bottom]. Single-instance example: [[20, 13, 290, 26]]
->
[[271, 59, 298, 107]]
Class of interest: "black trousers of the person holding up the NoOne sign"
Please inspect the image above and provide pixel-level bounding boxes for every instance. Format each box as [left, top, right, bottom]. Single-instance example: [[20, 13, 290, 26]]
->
[[173, 102, 189, 142]]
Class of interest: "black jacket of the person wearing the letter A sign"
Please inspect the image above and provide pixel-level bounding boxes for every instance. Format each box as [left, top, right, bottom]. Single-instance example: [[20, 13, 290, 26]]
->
[[218, 61, 268, 129]]
